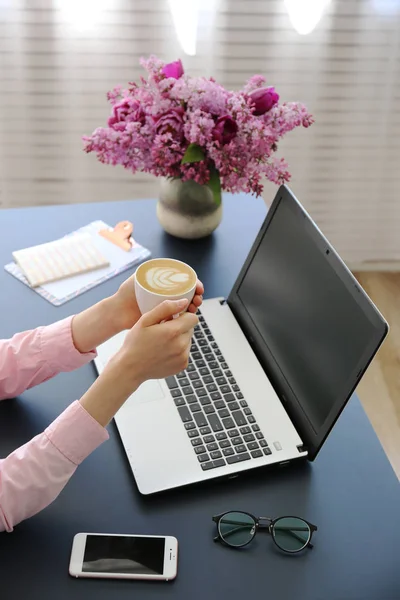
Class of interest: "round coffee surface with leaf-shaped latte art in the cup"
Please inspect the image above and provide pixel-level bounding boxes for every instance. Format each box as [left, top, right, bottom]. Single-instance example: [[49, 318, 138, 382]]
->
[[136, 258, 197, 297]]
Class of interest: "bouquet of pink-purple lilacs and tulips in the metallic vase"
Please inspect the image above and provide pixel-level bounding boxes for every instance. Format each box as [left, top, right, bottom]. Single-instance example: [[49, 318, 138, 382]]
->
[[83, 56, 313, 203]]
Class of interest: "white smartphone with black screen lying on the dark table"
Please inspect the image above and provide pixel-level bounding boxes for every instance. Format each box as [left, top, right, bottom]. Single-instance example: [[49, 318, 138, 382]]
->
[[69, 533, 178, 581]]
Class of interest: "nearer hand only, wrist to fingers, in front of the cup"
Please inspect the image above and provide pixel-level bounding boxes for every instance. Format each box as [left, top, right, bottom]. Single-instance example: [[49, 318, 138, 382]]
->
[[116, 300, 198, 385]]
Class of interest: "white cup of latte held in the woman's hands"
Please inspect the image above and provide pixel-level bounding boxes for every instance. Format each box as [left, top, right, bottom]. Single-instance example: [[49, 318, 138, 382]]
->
[[135, 258, 197, 314]]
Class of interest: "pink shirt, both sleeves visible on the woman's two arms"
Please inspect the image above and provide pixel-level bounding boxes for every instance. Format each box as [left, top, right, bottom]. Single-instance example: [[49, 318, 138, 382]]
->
[[0, 318, 108, 531]]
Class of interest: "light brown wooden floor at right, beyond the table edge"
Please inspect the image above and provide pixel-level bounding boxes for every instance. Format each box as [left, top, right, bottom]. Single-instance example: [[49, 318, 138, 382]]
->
[[355, 273, 400, 479]]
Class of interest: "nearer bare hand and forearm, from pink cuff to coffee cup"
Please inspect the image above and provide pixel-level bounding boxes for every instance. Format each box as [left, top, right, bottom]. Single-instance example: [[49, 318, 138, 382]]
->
[[81, 300, 198, 426]]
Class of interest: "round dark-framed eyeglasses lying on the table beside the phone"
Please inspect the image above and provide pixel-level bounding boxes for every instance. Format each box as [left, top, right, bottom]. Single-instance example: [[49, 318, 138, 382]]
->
[[212, 511, 317, 554]]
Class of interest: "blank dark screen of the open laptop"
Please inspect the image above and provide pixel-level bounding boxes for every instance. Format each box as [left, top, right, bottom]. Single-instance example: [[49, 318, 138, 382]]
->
[[238, 201, 372, 432]]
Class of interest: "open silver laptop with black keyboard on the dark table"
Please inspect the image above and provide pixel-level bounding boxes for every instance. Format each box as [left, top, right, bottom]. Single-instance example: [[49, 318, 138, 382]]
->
[[95, 186, 388, 494]]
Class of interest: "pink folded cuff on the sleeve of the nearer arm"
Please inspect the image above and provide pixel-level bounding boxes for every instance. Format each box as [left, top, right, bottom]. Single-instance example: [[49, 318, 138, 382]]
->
[[45, 400, 109, 465]]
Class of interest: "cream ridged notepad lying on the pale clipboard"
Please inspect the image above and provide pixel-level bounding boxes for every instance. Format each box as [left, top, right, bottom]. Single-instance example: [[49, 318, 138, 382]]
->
[[13, 233, 110, 287]]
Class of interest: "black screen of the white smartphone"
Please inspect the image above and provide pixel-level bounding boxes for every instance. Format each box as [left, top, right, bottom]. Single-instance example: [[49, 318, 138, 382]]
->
[[82, 535, 165, 575]]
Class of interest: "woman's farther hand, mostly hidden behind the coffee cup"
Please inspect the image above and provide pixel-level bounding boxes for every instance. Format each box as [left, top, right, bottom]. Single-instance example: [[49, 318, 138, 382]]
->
[[112, 275, 204, 330]]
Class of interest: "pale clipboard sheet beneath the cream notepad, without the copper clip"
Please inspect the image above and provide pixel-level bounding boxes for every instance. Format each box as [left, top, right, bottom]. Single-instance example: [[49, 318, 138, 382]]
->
[[4, 221, 151, 306]]
